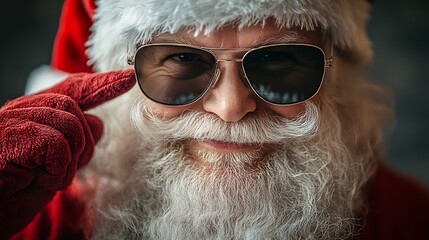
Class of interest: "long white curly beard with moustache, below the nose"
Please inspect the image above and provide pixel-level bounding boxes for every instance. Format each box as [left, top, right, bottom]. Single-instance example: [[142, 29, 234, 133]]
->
[[87, 92, 367, 239]]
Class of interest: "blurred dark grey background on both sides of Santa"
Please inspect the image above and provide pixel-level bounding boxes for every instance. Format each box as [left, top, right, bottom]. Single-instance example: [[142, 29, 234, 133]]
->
[[0, 0, 429, 186]]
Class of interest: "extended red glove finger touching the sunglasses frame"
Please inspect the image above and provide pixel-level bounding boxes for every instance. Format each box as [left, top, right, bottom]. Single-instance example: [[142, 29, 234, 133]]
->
[[41, 70, 136, 111]]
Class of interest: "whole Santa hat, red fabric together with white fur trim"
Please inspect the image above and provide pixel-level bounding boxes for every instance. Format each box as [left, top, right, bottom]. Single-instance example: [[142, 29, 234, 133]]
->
[[52, 0, 372, 72]]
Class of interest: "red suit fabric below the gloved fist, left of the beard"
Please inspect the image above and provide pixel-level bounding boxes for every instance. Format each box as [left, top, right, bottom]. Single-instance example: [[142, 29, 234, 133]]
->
[[11, 185, 90, 240]]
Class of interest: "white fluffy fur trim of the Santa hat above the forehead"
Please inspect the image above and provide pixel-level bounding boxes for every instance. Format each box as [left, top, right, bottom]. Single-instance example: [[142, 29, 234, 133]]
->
[[88, 0, 371, 71]]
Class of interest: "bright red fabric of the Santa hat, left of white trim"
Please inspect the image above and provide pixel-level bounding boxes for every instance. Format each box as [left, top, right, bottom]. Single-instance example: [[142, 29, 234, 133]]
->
[[51, 0, 95, 73]]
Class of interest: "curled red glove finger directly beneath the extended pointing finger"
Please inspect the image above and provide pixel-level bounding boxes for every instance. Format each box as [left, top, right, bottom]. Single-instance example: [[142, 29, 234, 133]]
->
[[0, 93, 103, 171]]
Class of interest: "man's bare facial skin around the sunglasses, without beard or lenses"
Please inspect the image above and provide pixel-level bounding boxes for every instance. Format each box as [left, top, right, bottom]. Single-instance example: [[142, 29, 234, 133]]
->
[[140, 21, 326, 166]]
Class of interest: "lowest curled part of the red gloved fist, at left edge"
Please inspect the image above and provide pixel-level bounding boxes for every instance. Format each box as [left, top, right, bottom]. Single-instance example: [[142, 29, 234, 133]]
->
[[0, 119, 72, 191]]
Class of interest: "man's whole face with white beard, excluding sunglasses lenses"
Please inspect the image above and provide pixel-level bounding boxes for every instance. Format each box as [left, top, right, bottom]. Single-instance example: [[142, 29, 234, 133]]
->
[[89, 22, 361, 239]]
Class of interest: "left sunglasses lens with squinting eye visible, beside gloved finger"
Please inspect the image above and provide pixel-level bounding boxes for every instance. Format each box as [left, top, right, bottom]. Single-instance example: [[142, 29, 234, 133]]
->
[[135, 45, 216, 105]]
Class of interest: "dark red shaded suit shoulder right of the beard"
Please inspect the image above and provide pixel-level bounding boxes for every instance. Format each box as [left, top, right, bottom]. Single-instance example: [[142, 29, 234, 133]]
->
[[361, 166, 429, 240]]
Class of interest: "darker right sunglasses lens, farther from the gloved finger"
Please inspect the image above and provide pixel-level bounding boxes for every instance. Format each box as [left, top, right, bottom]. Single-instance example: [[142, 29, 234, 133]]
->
[[243, 45, 325, 104]]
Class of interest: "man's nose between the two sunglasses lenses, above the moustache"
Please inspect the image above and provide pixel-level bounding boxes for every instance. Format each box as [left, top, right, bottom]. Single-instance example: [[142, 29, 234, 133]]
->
[[203, 62, 256, 122]]
